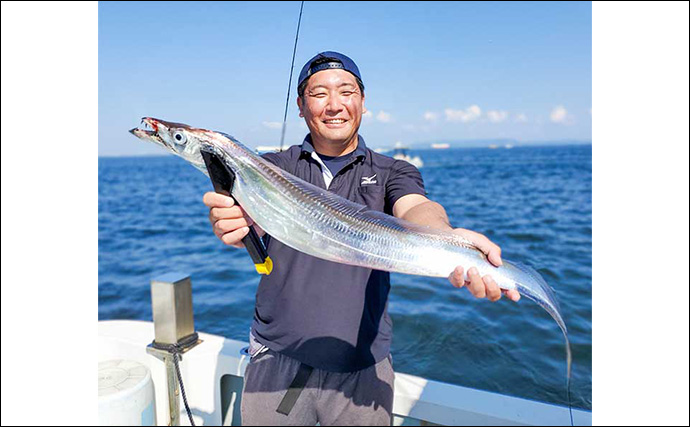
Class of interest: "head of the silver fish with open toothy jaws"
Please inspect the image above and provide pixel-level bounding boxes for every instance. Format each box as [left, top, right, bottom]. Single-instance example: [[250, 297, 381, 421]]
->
[[129, 117, 213, 172]]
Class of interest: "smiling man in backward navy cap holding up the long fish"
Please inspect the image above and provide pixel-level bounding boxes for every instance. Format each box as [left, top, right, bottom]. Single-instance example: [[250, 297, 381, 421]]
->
[[204, 52, 520, 425]]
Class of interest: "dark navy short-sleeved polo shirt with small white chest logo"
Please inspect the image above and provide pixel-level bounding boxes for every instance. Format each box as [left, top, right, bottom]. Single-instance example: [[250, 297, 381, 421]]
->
[[252, 135, 425, 372]]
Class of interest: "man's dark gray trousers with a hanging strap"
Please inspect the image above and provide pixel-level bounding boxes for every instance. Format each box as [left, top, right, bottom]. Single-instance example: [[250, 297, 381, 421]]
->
[[242, 350, 394, 426]]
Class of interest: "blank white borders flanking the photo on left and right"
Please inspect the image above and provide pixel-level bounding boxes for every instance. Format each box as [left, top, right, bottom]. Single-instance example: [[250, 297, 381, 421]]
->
[[0, 2, 689, 425]]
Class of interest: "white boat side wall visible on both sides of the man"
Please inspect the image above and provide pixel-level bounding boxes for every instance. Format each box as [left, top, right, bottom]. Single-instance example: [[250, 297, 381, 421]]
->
[[98, 320, 592, 425]]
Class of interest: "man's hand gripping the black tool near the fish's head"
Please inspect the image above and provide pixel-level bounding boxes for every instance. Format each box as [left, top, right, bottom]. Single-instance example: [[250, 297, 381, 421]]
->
[[204, 191, 265, 248]]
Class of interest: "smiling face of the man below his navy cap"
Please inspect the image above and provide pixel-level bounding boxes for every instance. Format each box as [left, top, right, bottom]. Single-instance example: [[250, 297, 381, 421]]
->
[[297, 69, 366, 149]]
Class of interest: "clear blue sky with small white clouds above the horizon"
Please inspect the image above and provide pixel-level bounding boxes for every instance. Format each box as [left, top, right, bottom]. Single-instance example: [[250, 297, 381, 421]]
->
[[98, 2, 592, 155]]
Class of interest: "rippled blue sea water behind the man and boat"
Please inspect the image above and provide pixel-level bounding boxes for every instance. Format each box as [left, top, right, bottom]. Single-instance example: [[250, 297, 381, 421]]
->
[[98, 145, 592, 409]]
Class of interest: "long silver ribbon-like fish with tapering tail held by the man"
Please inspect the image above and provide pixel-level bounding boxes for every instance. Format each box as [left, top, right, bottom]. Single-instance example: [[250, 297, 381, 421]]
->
[[130, 117, 571, 388]]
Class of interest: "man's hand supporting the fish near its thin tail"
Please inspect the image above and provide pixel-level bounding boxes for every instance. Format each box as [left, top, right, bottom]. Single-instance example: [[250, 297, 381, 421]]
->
[[448, 228, 520, 302]]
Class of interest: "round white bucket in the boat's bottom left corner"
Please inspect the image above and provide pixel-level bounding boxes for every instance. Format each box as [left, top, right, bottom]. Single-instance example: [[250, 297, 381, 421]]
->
[[98, 360, 156, 426]]
